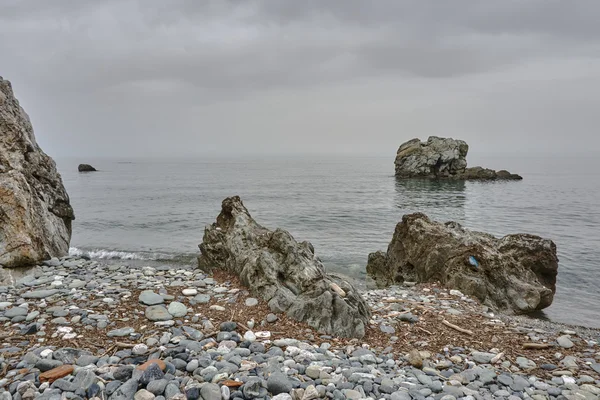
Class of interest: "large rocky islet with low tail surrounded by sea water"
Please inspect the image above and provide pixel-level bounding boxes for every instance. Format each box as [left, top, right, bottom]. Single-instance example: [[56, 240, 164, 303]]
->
[[395, 136, 523, 180]]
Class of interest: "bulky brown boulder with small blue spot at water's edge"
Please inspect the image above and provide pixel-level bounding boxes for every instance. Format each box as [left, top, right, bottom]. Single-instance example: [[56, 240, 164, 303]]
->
[[367, 213, 558, 314]]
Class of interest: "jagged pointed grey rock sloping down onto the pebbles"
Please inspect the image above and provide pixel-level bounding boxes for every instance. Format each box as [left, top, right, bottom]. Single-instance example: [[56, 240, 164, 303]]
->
[[198, 196, 370, 338]]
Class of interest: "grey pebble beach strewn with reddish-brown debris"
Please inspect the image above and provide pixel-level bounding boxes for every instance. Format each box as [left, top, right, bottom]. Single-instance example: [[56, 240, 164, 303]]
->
[[0, 258, 600, 400]]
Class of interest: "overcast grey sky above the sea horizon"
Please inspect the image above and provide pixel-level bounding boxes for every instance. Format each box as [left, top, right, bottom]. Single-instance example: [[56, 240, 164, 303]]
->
[[0, 0, 600, 159]]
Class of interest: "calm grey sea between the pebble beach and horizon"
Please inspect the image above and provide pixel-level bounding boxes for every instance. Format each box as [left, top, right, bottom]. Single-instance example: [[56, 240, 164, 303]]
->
[[57, 157, 600, 327]]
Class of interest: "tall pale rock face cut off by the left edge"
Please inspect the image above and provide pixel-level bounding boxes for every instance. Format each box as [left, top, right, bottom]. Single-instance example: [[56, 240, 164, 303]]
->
[[0, 77, 75, 267]]
